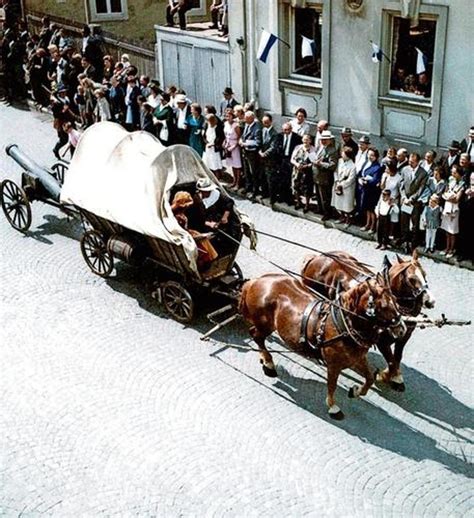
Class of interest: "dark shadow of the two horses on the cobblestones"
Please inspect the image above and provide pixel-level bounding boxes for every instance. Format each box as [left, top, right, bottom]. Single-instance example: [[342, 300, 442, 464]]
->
[[212, 329, 473, 477]]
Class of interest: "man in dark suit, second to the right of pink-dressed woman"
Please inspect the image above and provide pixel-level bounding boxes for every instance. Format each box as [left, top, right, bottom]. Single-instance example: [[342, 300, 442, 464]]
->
[[258, 113, 278, 208]]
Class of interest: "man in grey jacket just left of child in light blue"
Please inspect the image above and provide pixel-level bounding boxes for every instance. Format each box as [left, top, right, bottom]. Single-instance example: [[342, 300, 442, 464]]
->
[[400, 153, 428, 253]]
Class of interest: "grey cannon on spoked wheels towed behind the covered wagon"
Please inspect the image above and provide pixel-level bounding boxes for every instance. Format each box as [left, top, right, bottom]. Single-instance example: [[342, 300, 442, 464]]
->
[[0, 144, 69, 232]]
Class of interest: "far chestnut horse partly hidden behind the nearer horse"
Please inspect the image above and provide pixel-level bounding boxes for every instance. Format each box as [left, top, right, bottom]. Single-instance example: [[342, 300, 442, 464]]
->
[[301, 250, 435, 392]]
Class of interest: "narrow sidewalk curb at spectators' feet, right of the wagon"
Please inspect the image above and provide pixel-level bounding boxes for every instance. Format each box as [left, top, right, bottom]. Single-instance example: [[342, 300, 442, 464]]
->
[[228, 189, 474, 271]]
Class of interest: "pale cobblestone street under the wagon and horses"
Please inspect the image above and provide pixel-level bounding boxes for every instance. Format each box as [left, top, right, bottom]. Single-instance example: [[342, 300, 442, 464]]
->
[[0, 105, 473, 517]]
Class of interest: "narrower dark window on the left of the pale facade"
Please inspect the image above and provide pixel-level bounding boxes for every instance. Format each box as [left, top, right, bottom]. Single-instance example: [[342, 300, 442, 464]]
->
[[291, 7, 323, 79]]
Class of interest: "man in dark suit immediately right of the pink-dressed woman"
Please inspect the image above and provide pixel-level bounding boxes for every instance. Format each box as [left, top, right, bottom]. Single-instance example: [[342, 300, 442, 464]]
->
[[240, 111, 262, 197]]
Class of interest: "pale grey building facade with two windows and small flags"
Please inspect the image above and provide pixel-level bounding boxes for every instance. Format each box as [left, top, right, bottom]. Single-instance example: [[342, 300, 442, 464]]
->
[[229, 0, 474, 149]]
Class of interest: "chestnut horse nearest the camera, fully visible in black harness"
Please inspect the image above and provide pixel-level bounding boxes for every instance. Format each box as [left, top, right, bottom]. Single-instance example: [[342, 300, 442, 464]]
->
[[240, 274, 406, 419]]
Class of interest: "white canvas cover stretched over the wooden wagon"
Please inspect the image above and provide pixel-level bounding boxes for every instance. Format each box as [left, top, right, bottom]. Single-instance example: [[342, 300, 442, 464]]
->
[[61, 122, 218, 271]]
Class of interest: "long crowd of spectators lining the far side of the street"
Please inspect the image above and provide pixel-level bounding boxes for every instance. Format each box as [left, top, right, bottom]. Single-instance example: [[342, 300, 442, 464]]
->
[[1, 17, 474, 260]]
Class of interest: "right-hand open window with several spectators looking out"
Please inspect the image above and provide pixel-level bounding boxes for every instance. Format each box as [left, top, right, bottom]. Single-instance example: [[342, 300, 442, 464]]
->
[[390, 16, 436, 100]]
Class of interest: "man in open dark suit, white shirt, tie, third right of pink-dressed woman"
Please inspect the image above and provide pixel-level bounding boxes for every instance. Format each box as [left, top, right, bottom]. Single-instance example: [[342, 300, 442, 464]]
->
[[273, 122, 301, 205]]
